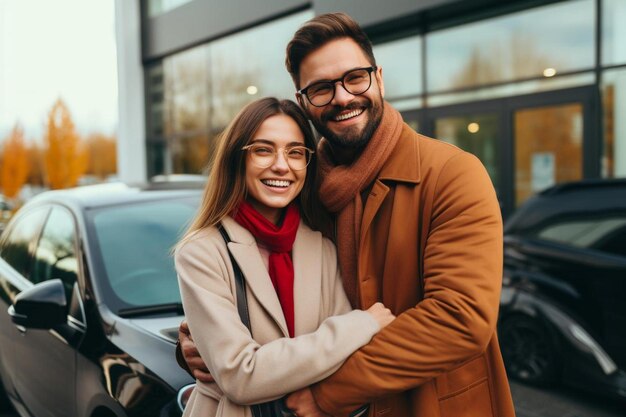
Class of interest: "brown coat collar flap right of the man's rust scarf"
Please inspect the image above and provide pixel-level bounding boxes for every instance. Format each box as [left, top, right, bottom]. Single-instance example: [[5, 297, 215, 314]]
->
[[378, 123, 421, 184]]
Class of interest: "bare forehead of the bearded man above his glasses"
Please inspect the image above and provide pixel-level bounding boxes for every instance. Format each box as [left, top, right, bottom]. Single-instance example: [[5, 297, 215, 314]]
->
[[300, 38, 370, 86]]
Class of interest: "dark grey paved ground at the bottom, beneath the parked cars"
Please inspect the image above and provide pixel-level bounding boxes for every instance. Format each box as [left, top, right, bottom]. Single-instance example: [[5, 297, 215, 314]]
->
[[0, 382, 626, 417]]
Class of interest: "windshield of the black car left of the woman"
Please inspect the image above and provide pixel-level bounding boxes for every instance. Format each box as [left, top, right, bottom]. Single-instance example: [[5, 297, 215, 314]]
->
[[92, 197, 198, 308]]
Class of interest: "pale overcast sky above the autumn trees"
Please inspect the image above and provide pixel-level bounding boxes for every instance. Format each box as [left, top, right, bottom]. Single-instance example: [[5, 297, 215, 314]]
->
[[0, 0, 118, 140]]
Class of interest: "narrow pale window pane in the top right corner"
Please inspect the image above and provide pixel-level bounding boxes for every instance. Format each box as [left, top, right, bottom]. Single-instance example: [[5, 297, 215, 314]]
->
[[602, 0, 626, 65]]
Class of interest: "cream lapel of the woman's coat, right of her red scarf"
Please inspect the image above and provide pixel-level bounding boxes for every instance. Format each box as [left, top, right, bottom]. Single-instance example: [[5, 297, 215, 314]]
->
[[292, 223, 322, 335]]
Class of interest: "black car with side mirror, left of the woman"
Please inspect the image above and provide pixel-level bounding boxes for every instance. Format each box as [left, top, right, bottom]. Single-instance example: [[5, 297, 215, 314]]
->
[[0, 184, 201, 417]]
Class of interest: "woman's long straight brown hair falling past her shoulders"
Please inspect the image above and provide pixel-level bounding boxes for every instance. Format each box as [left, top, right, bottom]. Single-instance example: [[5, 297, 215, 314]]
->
[[182, 97, 329, 241]]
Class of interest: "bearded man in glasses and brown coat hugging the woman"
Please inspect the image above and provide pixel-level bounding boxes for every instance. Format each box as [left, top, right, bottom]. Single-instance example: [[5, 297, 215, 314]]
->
[[181, 13, 514, 417]]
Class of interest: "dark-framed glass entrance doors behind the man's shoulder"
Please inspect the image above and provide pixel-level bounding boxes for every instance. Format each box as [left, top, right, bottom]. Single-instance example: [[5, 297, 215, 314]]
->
[[424, 87, 602, 216]]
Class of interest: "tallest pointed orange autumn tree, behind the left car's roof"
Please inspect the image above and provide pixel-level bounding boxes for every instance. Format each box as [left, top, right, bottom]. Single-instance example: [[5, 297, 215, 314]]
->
[[44, 98, 87, 189]]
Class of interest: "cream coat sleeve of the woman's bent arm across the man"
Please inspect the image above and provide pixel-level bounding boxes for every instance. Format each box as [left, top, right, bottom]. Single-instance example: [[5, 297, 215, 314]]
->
[[175, 237, 379, 404]]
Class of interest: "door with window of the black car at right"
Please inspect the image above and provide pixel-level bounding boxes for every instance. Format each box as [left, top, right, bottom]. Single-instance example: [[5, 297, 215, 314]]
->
[[535, 208, 626, 369]]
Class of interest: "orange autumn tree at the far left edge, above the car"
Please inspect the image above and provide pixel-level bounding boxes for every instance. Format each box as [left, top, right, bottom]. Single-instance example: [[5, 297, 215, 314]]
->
[[1, 124, 29, 198]]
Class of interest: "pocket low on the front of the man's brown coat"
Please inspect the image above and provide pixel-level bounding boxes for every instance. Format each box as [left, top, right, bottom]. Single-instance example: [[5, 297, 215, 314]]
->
[[435, 355, 493, 417]]
